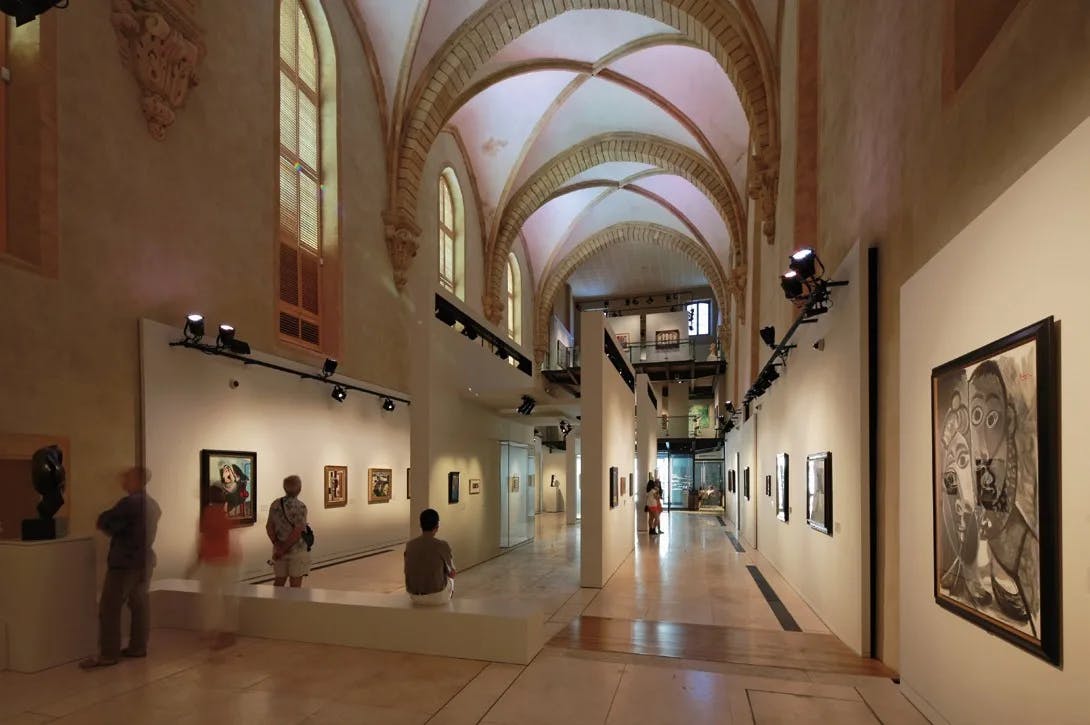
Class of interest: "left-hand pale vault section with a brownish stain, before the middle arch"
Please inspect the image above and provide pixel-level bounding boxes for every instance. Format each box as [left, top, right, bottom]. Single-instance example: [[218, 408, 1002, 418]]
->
[[450, 71, 576, 208]]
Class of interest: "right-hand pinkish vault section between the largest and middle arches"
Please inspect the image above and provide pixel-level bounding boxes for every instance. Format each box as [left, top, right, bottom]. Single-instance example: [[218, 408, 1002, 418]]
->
[[609, 46, 749, 189]]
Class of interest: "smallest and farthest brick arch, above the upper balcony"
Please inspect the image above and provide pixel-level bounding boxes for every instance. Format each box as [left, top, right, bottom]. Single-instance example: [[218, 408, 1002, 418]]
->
[[534, 221, 730, 363]]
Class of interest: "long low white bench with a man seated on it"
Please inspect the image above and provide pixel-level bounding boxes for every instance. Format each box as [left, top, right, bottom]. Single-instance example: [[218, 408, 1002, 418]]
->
[[152, 579, 545, 665]]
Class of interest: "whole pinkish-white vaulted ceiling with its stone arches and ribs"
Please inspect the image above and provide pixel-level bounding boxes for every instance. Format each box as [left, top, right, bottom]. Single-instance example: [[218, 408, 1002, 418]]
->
[[351, 0, 778, 351]]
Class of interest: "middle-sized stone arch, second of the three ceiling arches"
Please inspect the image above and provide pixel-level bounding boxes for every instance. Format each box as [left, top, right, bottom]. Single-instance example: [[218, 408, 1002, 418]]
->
[[484, 133, 746, 321]]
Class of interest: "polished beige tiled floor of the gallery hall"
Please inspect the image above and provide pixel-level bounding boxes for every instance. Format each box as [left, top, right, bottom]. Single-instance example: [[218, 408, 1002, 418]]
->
[[0, 515, 927, 725]]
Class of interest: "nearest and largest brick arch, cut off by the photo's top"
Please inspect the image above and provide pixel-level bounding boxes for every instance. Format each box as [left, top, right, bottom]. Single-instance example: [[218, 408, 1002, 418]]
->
[[384, 0, 779, 287]]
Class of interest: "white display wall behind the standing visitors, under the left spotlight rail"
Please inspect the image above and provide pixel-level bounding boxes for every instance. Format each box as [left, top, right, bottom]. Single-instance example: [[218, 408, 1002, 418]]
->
[[136, 319, 409, 578]]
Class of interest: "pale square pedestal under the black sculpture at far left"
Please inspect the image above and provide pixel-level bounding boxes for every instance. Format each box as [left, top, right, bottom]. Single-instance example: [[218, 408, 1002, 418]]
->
[[0, 536, 98, 673]]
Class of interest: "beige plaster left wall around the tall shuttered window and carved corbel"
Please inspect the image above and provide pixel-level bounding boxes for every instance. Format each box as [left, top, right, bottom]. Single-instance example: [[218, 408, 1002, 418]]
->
[[0, 0, 408, 571]]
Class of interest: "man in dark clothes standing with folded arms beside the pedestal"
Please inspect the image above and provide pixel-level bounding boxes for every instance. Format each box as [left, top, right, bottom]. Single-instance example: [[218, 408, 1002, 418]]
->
[[80, 466, 161, 669]]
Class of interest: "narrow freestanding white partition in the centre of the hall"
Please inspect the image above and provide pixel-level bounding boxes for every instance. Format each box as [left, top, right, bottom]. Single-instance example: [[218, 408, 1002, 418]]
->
[[580, 312, 635, 588]]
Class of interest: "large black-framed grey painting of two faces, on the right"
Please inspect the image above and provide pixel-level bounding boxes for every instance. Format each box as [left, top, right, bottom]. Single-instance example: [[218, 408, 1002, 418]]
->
[[931, 317, 1062, 666]]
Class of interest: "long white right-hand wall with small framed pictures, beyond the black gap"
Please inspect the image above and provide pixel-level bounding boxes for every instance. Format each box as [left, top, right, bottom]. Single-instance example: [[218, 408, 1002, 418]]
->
[[727, 245, 870, 654]]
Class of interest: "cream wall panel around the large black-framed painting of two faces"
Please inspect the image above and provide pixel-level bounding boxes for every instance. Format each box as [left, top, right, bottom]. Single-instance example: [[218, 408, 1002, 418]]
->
[[900, 116, 1090, 724]]
